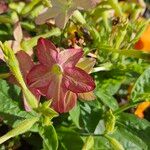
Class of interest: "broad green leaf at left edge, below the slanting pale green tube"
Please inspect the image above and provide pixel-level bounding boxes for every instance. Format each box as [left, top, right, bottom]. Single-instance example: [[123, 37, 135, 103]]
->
[[0, 80, 33, 125]]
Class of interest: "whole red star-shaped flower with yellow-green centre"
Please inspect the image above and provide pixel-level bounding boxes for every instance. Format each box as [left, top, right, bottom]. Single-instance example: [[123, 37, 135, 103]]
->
[[27, 38, 95, 113]]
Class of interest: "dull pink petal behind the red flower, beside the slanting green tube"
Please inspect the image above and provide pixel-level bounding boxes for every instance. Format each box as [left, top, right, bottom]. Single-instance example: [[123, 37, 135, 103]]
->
[[16, 51, 34, 81]]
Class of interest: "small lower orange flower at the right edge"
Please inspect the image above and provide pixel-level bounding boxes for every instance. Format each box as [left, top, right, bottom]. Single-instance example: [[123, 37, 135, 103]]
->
[[134, 102, 150, 118]]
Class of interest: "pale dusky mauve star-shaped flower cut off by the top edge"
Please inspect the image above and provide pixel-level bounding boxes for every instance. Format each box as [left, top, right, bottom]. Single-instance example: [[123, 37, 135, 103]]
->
[[35, 0, 100, 28]]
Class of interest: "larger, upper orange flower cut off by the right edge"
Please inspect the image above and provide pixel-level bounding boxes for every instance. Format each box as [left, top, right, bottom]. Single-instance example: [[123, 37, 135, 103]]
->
[[135, 25, 150, 52]]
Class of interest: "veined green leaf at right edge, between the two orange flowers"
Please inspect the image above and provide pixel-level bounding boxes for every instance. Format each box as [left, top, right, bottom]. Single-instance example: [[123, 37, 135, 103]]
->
[[131, 67, 150, 101]]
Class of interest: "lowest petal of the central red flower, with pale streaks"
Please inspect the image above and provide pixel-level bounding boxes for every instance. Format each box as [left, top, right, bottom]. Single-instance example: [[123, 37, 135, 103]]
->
[[46, 75, 77, 113]]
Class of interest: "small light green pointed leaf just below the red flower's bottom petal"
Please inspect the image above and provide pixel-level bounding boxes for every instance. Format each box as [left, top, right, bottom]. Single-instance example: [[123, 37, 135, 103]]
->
[[69, 104, 81, 128]]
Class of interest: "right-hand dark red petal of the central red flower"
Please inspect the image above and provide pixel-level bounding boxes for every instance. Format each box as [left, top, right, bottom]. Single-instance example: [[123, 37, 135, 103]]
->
[[63, 67, 95, 93]]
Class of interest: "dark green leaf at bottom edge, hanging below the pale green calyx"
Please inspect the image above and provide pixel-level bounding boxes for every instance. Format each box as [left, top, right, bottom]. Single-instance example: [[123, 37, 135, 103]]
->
[[39, 126, 58, 150]]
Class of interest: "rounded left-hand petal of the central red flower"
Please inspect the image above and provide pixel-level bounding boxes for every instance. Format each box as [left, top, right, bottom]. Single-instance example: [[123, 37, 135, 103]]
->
[[27, 64, 51, 88]]
